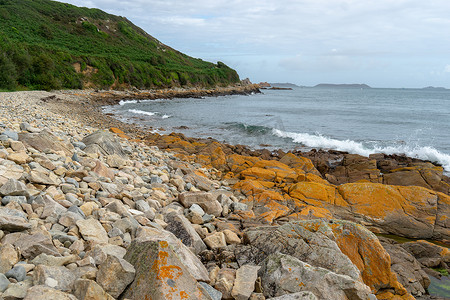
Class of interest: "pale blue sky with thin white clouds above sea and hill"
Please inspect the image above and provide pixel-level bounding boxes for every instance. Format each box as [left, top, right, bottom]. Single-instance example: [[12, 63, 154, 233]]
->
[[63, 0, 450, 88]]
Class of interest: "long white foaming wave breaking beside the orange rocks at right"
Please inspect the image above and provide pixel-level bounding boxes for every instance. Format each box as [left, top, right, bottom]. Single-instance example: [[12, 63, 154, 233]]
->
[[272, 129, 450, 172]]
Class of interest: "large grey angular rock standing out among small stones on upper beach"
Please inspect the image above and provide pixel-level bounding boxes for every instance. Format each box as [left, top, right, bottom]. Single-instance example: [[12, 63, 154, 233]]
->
[[81, 130, 126, 158]]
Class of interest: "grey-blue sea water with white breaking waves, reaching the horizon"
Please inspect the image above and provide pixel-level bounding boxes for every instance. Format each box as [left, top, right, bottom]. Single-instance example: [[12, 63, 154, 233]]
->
[[104, 88, 450, 172]]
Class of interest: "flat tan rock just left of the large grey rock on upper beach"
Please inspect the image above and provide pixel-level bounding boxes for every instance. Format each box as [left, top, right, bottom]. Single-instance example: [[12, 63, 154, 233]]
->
[[19, 130, 73, 155]]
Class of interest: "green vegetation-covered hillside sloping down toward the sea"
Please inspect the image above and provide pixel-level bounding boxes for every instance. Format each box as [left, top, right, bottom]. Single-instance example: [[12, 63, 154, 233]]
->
[[0, 0, 239, 90]]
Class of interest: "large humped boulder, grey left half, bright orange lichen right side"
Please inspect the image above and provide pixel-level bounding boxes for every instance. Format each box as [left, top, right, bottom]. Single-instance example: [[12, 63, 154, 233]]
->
[[235, 220, 410, 299]]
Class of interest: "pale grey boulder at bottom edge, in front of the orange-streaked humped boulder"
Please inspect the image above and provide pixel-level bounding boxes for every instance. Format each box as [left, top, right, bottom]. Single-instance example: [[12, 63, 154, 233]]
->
[[259, 254, 370, 300]]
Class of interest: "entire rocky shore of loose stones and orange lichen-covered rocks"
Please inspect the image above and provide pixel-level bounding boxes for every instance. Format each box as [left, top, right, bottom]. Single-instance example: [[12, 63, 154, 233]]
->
[[0, 88, 450, 300]]
